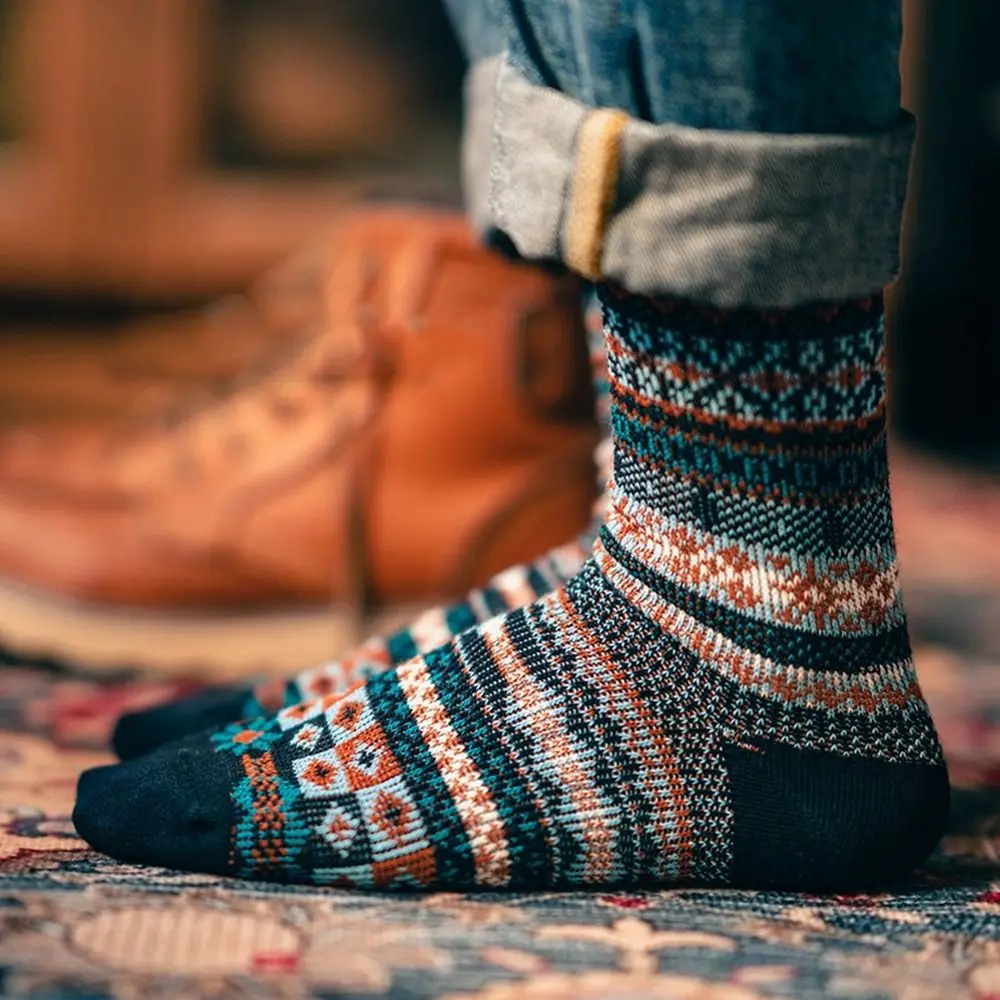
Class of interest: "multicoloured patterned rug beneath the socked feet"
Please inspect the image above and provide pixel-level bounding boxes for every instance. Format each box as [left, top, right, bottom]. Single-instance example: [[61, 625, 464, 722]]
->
[[0, 454, 1000, 1000]]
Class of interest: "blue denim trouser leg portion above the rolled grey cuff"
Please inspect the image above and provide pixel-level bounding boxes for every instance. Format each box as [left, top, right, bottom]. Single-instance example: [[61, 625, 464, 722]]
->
[[446, 0, 902, 134]]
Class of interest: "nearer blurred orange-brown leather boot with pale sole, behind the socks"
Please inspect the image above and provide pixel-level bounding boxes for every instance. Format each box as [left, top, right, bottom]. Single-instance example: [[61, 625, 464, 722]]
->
[[0, 208, 597, 676]]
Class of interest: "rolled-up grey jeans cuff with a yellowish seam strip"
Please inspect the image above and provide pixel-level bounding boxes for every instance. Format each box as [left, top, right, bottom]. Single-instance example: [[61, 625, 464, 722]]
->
[[465, 56, 914, 308]]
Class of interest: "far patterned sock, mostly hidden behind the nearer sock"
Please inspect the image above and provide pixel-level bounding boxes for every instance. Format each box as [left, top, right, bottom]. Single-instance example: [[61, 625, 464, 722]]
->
[[111, 296, 611, 760]]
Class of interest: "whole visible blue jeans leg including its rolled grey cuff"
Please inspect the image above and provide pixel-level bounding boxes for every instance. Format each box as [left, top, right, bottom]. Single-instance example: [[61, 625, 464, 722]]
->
[[446, 0, 912, 306]]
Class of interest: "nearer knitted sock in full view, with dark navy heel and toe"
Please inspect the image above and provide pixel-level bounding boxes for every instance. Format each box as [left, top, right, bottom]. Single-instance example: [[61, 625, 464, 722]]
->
[[74, 290, 948, 890]]
